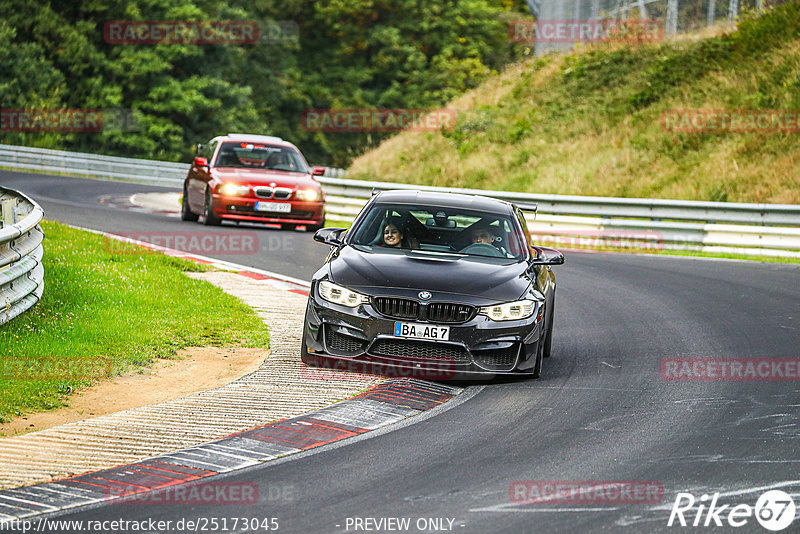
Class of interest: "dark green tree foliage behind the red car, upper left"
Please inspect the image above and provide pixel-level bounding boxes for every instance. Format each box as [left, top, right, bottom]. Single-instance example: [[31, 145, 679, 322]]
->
[[0, 0, 525, 165]]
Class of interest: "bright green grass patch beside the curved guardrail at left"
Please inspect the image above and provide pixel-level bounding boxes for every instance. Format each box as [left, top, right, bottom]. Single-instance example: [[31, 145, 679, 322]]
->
[[0, 222, 269, 422]]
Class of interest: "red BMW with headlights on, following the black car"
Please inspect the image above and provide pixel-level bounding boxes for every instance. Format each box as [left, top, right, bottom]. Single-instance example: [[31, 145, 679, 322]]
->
[[181, 134, 325, 231]]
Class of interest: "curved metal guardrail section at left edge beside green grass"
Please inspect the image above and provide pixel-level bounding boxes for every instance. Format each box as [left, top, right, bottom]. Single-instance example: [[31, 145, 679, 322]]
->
[[0, 187, 44, 325]]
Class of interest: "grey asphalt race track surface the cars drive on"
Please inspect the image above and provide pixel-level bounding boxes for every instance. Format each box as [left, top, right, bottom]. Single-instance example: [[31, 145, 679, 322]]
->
[[0, 171, 800, 533]]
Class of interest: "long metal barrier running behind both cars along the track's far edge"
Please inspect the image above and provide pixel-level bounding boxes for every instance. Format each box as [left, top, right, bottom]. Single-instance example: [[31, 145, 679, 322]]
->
[[0, 145, 800, 257]]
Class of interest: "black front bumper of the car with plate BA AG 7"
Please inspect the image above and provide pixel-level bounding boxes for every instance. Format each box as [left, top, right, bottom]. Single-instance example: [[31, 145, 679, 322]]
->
[[303, 284, 541, 380]]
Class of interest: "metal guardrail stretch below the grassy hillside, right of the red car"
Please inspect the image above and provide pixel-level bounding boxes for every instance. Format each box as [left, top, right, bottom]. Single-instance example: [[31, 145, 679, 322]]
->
[[320, 184, 800, 258]]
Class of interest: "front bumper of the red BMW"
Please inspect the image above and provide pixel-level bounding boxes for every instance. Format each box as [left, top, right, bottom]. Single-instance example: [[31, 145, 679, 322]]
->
[[213, 194, 325, 226]]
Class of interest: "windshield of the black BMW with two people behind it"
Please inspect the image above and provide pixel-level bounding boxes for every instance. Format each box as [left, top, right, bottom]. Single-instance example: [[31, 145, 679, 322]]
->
[[350, 204, 526, 260]]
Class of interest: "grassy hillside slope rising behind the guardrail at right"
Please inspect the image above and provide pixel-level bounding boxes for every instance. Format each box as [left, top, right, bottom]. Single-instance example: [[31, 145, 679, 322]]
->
[[350, 1, 800, 203]]
